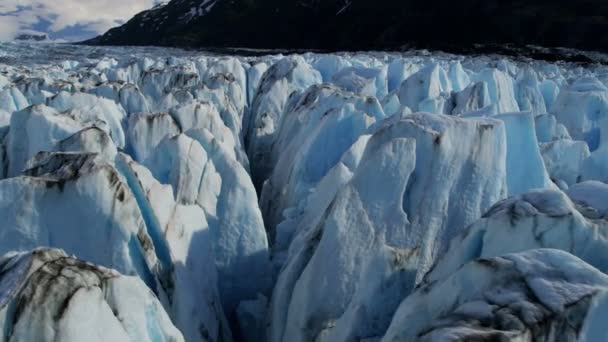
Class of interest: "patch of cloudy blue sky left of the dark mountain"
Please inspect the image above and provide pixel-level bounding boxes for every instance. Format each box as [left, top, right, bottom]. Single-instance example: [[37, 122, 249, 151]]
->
[[0, 0, 159, 41]]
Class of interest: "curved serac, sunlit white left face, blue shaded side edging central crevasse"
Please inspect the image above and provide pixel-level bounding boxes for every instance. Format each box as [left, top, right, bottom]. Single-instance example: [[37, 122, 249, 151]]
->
[[144, 133, 270, 315]]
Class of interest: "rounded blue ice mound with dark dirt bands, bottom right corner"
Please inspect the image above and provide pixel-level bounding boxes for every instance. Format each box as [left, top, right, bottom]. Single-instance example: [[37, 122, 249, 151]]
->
[[382, 249, 608, 342]]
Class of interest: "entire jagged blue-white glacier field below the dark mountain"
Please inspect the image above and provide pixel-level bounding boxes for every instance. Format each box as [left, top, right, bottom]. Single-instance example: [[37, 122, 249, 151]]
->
[[0, 43, 608, 342]]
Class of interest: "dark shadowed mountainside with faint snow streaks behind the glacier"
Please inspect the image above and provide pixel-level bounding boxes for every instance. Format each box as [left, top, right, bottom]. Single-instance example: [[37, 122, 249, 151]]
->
[[86, 0, 608, 51]]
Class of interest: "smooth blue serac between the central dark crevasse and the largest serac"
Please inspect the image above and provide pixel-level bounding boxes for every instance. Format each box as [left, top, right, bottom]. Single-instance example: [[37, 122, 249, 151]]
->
[[260, 85, 385, 234]]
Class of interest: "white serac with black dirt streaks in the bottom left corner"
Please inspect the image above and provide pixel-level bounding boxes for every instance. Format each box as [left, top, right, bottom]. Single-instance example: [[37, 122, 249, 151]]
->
[[0, 249, 184, 342]]
